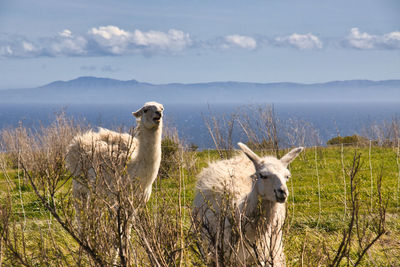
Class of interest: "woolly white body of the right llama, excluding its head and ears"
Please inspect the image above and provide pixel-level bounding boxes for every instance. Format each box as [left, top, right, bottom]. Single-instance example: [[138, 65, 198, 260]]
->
[[194, 154, 286, 266]]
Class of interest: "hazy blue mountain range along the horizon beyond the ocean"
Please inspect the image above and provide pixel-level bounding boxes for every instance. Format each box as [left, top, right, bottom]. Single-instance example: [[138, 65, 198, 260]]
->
[[0, 77, 400, 104]]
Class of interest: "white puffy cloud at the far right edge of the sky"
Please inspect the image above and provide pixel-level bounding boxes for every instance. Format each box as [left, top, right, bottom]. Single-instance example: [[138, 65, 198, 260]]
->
[[345, 27, 400, 50]]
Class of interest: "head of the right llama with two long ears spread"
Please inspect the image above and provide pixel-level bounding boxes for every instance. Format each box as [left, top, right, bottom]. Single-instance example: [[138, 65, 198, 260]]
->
[[238, 143, 303, 203]]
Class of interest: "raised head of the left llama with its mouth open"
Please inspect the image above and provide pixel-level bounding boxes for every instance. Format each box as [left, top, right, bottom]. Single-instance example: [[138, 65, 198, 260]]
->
[[132, 102, 164, 129]]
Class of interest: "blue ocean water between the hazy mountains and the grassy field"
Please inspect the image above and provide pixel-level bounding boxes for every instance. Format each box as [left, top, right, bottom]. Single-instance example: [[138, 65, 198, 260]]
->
[[0, 103, 400, 149]]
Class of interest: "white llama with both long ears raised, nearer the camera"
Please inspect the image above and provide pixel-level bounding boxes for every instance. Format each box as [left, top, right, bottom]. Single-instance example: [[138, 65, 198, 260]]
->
[[194, 143, 303, 266]]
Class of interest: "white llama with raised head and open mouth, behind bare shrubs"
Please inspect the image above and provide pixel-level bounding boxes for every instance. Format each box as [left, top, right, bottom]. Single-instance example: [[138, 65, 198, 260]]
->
[[66, 102, 164, 264]]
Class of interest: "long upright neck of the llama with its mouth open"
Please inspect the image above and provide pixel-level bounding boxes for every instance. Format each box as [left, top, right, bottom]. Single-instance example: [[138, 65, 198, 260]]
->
[[128, 122, 162, 199]]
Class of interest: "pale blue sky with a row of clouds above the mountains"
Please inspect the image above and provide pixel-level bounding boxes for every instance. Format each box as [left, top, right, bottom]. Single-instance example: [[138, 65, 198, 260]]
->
[[0, 0, 400, 89]]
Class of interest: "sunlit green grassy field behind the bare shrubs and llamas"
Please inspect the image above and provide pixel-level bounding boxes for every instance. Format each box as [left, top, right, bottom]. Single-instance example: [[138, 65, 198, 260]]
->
[[0, 146, 400, 266]]
